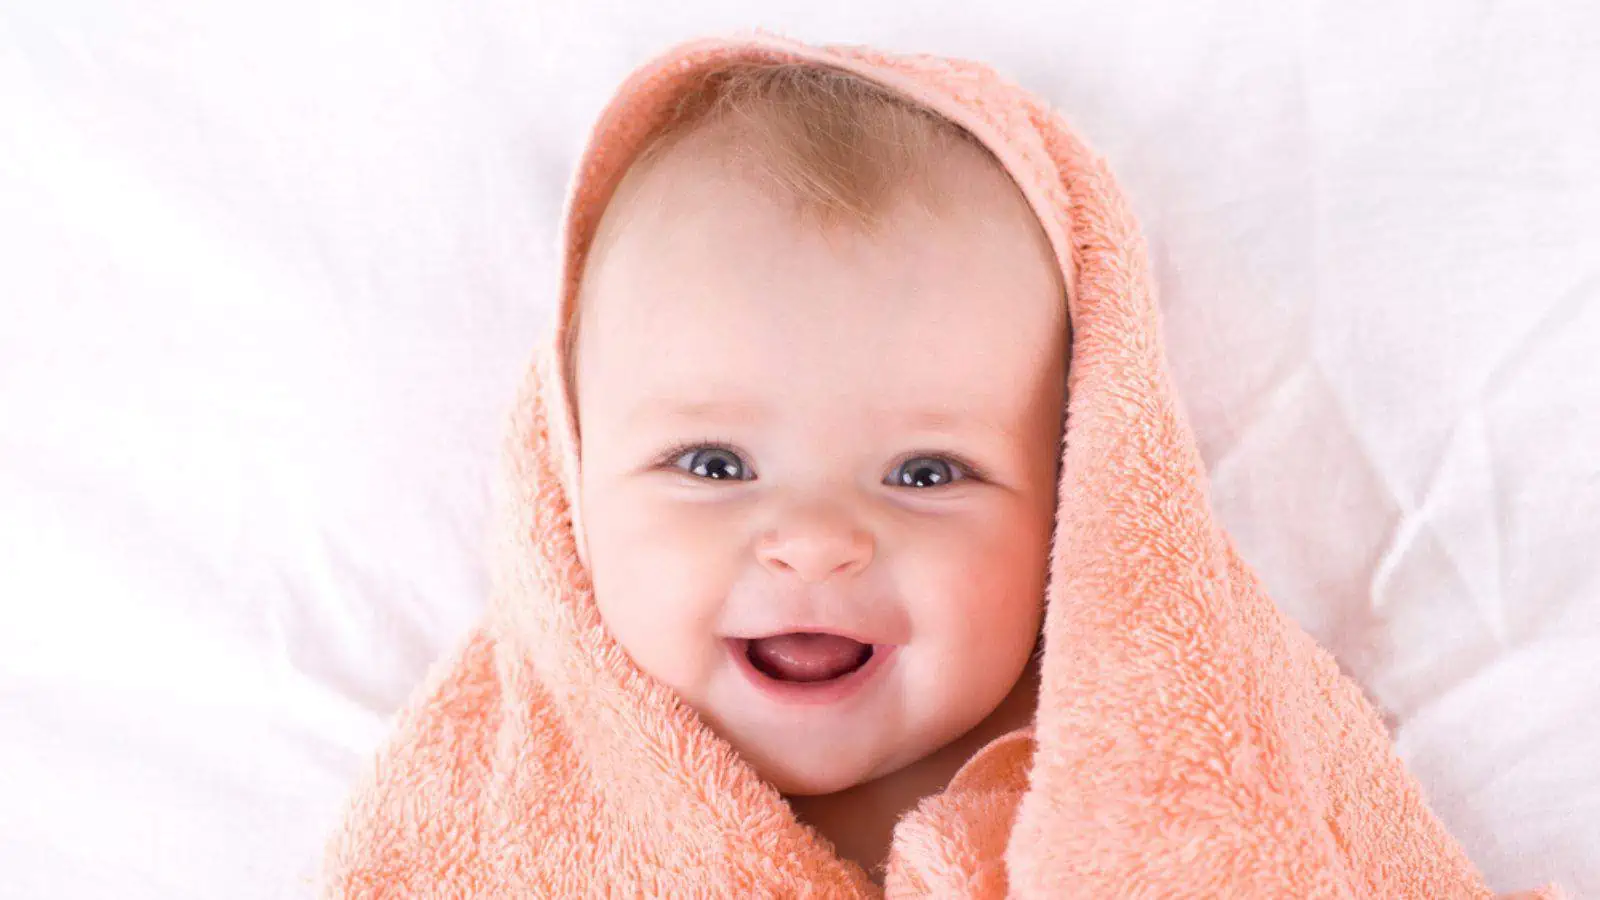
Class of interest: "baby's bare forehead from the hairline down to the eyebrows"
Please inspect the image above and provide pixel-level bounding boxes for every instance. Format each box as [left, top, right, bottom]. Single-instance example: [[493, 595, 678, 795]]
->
[[579, 120, 1066, 422]]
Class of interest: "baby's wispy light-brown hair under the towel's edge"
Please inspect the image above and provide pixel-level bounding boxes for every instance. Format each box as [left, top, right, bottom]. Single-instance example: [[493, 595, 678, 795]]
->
[[562, 62, 1003, 384]]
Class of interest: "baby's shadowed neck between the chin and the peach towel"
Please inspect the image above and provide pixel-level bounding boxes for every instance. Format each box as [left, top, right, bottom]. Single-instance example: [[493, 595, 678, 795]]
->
[[787, 658, 1038, 884]]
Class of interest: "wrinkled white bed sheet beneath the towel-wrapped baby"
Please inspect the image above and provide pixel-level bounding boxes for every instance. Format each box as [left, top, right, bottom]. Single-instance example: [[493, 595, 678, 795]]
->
[[0, 0, 1600, 900]]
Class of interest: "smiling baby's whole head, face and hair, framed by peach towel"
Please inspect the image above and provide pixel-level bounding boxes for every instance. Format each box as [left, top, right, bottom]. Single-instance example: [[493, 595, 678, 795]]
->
[[566, 64, 1067, 794]]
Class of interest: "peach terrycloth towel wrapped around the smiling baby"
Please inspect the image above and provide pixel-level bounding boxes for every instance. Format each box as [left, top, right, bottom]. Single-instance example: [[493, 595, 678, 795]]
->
[[315, 29, 1557, 898]]
